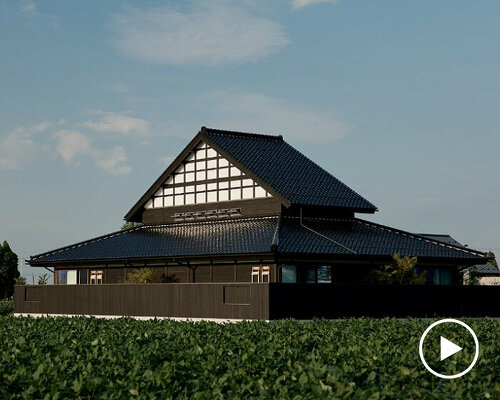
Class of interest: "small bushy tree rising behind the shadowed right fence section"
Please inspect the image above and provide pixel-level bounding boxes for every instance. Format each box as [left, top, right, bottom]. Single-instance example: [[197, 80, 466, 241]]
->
[[372, 254, 426, 285]]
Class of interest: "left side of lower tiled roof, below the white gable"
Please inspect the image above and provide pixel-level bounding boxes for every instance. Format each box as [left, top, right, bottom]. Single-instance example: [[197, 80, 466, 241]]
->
[[30, 216, 278, 264]]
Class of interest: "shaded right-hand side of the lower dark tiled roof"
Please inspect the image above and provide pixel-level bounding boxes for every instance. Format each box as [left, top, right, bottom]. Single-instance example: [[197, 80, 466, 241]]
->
[[278, 217, 484, 259]]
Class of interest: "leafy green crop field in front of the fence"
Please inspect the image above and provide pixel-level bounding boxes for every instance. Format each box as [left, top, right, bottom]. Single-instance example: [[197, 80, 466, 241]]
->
[[0, 316, 500, 400]]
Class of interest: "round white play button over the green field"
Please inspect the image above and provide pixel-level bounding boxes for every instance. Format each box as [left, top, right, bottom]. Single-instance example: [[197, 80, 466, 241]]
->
[[418, 318, 479, 379]]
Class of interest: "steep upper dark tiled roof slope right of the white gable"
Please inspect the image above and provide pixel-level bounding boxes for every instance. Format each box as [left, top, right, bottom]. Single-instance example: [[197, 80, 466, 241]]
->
[[202, 128, 376, 212]]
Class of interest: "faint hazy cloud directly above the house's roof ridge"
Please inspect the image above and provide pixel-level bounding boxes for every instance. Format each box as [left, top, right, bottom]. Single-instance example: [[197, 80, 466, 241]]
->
[[193, 91, 349, 142]]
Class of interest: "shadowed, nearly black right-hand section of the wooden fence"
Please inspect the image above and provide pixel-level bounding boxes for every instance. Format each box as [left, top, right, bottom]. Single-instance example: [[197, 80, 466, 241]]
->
[[269, 283, 500, 319]]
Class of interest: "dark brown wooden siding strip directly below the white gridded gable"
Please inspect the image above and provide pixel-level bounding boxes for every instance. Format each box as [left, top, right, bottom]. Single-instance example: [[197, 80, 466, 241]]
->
[[142, 198, 281, 224]]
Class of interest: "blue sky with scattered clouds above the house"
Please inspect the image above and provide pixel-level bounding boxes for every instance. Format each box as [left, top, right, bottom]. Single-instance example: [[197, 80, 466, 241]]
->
[[0, 0, 500, 282]]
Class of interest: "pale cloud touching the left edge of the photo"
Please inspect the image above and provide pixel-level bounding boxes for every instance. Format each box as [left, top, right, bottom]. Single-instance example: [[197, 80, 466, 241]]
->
[[0, 121, 50, 169]]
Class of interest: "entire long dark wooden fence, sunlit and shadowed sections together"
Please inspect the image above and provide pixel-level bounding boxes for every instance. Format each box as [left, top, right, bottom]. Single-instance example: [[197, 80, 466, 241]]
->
[[14, 283, 500, 320]]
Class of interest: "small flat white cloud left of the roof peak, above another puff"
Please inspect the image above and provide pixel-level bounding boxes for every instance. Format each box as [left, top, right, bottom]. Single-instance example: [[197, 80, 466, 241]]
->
[[82, 112, 149, 135]]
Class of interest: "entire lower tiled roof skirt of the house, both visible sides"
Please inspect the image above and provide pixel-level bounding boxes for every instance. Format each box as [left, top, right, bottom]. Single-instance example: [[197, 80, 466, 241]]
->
[[29, 215, 484, 265]]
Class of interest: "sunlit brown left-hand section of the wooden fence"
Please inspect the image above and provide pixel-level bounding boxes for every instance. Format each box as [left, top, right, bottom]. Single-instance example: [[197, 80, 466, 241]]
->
[[14, 283, 269, 320]]
